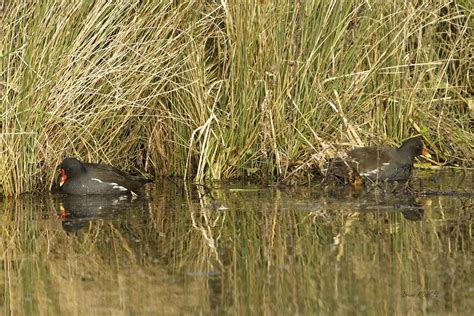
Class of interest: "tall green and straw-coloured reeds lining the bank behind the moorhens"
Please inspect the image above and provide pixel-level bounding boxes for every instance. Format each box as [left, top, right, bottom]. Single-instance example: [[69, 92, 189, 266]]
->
[[0, 0, 474, 195]]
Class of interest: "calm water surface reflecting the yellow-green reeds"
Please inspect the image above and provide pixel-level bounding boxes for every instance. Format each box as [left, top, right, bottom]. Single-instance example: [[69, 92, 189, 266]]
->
[[0, 170, 474, 315]]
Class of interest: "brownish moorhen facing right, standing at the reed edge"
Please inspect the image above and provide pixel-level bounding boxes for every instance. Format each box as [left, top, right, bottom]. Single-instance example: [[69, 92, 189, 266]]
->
[[328, 137, 427, 182]]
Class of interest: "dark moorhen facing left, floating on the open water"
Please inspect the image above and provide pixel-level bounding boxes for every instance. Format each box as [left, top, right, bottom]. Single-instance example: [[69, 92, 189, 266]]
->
[[59, 158, 152, 195]]
